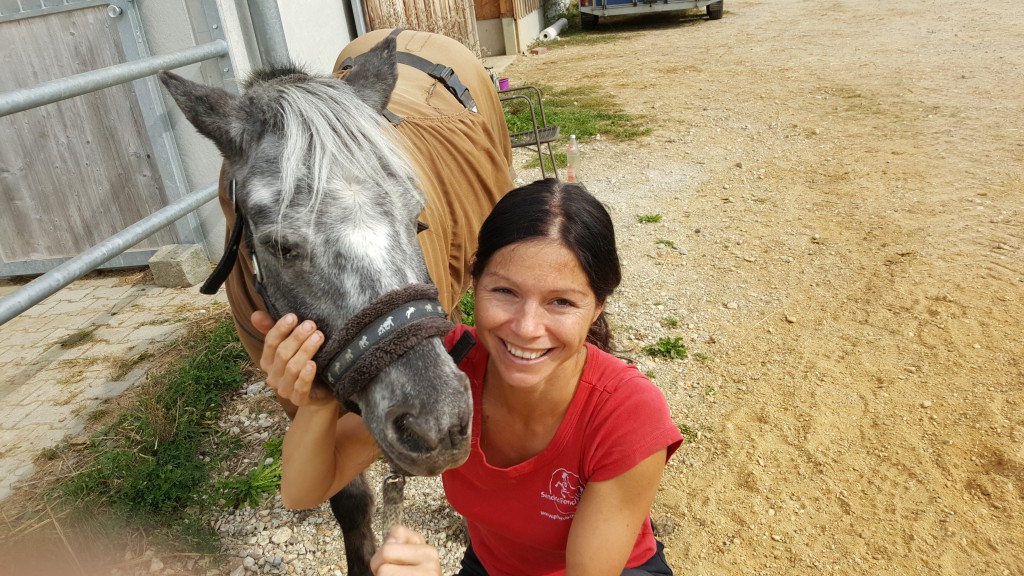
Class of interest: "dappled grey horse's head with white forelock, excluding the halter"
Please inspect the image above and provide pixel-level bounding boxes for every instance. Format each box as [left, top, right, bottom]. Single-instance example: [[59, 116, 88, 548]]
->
[[160, 38, 472, 476]]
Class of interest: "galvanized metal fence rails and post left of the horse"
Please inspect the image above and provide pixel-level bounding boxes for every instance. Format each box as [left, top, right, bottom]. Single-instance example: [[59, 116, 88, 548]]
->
[[0, 0, 289, 325]]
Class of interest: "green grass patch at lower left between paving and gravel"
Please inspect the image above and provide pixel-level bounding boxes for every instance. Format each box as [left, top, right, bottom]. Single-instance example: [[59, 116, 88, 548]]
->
[[51, 317, 249, 550]]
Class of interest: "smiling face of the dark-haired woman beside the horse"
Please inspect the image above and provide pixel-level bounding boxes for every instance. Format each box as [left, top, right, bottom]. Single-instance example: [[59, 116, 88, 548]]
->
[[474, 239, 603, 387]]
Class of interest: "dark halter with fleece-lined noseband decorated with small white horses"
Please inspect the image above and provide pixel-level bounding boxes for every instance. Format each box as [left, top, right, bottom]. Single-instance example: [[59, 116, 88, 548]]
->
[[200, 179, 473, 413]]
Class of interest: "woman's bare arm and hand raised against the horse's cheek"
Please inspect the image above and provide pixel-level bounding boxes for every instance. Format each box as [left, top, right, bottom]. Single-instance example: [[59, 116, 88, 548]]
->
[[252, 312, 380, 509]]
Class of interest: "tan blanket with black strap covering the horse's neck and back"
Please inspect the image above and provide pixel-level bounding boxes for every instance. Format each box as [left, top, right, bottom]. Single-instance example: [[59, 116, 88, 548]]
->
[[220, 30, 512, 364]]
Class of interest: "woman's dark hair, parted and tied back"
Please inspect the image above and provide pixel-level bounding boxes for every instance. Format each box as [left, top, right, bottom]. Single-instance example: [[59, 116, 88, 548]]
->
[[472, 178, 623, 353]]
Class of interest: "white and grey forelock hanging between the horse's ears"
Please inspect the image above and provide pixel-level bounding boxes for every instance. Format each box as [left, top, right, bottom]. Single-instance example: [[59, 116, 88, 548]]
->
[[245, 66, 423, 226]]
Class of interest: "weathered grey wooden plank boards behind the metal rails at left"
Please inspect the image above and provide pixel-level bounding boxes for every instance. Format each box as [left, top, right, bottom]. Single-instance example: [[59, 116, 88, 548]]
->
[[0, 5, 175, 263]]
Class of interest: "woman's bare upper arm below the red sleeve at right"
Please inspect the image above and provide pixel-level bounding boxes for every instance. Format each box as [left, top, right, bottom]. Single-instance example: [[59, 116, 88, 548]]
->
[[565, 449, 667, 576]]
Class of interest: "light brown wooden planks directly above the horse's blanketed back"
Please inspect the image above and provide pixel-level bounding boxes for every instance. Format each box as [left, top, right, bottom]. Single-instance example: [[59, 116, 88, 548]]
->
[[365, 0, 480, 56]]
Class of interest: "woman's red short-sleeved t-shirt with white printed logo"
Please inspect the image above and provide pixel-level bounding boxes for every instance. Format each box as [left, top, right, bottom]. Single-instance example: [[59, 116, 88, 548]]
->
[[441, 326, 683, 576]]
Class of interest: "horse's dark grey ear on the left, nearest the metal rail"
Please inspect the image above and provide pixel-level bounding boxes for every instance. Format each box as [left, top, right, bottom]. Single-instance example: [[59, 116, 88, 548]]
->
[[159, 71, 241, 158]]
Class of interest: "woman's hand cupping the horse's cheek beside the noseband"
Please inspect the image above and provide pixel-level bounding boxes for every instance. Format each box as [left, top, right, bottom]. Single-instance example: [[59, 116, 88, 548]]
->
[[251, 311, 334, 406]]
